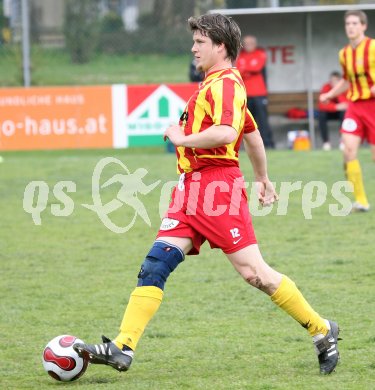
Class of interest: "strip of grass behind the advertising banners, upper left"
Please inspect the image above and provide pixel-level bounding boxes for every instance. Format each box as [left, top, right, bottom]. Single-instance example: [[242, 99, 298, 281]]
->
[[0, 47, 191, 87]]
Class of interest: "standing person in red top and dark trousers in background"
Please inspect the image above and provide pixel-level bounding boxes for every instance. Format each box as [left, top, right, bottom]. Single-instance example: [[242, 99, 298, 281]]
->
[[236, 35, 275, 148]]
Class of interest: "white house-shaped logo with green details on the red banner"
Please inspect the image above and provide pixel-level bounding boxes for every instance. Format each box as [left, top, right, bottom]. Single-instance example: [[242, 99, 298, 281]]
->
[[126, 85, 186, 146]]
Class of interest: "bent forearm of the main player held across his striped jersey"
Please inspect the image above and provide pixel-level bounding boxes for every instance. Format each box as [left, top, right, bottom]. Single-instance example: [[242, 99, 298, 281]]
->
[[164, 125, 238, 149]]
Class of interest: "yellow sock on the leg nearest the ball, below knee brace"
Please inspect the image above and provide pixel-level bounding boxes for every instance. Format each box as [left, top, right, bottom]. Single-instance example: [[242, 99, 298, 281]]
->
[[114, 286, 163, 351]]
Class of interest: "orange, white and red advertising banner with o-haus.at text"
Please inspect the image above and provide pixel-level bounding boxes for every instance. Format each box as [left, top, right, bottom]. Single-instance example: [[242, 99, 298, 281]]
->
[[0, 83, 197, 150]]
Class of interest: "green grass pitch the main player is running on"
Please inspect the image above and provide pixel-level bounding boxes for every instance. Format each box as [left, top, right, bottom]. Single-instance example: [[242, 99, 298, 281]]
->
[[0, 148, 375, 390]]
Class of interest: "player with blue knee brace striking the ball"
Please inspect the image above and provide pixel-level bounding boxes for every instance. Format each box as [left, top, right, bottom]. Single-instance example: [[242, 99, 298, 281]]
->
[[74, 14, 339, 374]]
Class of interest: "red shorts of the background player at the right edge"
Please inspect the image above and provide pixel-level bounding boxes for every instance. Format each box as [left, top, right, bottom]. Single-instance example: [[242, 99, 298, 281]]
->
[[340, 98, 375, 145]]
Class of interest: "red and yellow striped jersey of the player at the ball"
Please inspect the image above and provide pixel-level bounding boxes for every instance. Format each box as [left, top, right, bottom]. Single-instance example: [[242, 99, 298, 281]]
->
[[176, 68, 257, 173]]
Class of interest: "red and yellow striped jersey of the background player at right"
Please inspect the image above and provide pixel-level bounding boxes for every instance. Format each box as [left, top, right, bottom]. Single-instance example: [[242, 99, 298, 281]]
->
[[339, 37, 375, 101]]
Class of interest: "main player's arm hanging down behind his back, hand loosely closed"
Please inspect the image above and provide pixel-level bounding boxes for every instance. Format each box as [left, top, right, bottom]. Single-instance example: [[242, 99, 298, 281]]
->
[[243, 130, 279, 206]]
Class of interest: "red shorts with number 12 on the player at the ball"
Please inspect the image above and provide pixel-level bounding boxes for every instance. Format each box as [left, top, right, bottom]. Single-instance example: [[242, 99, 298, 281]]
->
[[157, 167, 257, 255]]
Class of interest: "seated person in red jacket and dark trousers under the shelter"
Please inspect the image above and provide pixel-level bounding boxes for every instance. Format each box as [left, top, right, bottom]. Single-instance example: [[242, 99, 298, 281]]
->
[[318, 72, 348, 150]]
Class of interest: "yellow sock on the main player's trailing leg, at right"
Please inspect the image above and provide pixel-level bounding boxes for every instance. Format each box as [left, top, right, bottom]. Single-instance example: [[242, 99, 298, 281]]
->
[[271, 275, 328, 336]]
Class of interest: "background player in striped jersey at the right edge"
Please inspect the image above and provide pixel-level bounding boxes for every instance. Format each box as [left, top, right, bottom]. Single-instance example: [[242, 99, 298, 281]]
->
[[320, 10, 375, 211]]
